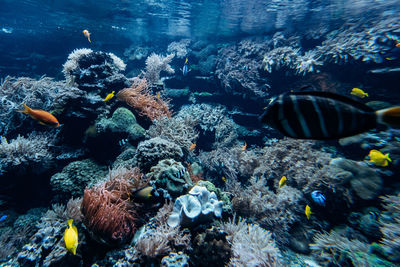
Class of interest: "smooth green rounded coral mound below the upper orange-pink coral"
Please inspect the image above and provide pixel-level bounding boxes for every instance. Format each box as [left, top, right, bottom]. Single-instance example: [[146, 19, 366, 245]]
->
[[96, 108, 145, 141]]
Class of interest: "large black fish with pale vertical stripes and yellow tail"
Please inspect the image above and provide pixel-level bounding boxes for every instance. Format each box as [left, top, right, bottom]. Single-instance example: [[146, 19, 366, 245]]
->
[[260, 91, 400, 140]]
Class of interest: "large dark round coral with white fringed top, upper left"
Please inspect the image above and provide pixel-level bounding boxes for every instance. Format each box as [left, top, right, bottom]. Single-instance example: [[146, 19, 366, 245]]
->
[[63, 48, 129, 94]]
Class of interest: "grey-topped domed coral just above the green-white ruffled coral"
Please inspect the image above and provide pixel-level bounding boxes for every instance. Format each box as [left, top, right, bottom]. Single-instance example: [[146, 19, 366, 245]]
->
[[136, 137, 183, 172]]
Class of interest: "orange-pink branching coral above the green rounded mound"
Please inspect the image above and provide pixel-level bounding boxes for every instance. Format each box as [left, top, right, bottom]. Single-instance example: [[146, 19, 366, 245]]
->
[[117, 77, 171, 121]]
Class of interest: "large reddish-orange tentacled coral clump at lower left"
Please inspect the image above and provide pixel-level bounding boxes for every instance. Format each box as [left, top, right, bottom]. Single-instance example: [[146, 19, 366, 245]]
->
[[81, 169, 142, 245]]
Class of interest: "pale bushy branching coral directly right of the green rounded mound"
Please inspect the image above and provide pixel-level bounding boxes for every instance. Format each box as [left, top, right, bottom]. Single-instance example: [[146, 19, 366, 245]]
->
[[146, 116, 199, 151]]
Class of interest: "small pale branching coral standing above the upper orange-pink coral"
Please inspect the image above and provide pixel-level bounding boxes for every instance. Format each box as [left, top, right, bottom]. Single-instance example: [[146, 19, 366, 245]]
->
[[145, 53, 175, 84]]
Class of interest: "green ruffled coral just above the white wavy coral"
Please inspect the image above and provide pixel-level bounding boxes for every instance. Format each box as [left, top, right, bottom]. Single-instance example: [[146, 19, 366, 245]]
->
[[146, 159, 193, 197]]
